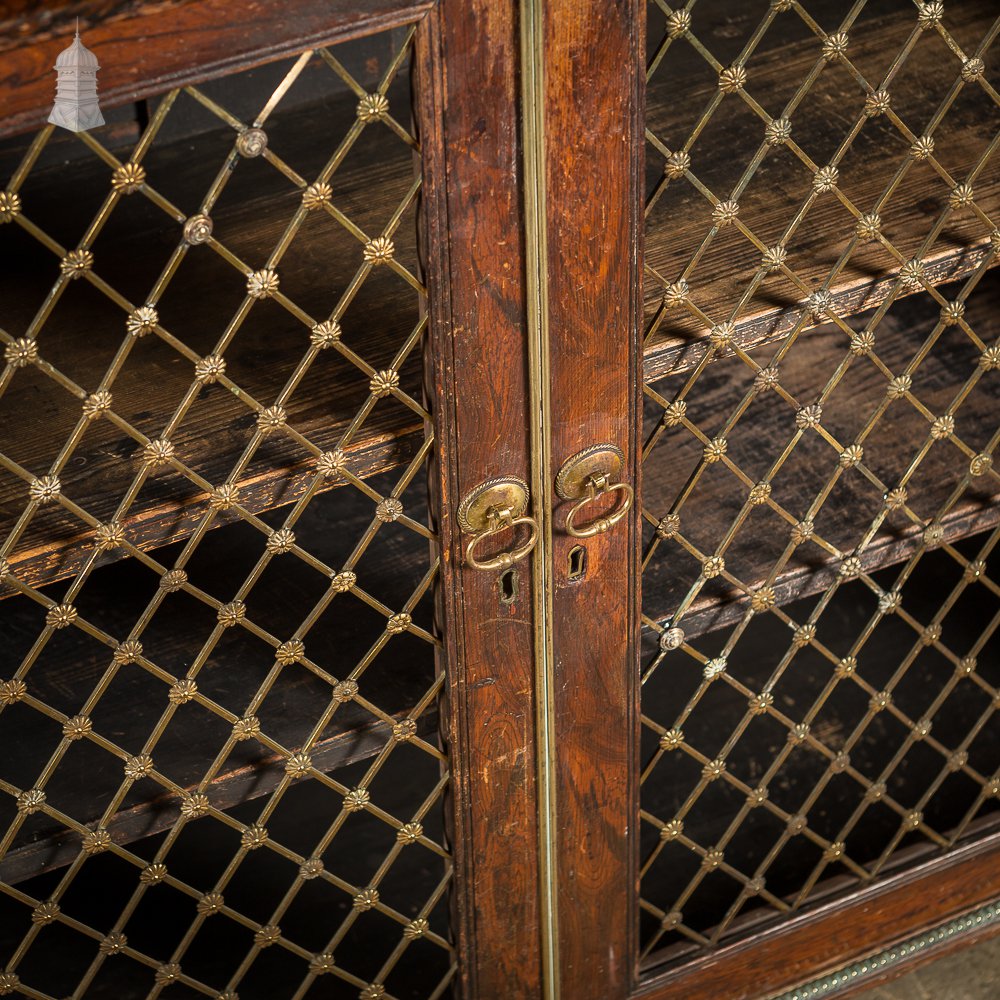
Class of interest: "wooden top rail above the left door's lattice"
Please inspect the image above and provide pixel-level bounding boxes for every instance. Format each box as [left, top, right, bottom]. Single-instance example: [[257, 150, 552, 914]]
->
[[0, 0, 432, 135]]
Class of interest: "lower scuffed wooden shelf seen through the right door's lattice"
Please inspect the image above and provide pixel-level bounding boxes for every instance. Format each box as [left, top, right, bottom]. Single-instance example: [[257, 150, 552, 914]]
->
[[643, 275, 1000, 635]]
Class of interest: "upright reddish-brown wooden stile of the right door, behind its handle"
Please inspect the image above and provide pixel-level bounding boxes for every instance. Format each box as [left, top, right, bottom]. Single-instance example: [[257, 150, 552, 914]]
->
[[541, 0, 645, 1000]]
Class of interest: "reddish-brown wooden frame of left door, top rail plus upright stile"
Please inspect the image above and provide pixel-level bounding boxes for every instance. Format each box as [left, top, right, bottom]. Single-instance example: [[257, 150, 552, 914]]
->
[[0, 0, 542, 997]]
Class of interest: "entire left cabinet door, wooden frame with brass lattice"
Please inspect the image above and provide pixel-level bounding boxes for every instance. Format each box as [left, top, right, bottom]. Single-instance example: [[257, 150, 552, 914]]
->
[[0, 0, 542, 1000]]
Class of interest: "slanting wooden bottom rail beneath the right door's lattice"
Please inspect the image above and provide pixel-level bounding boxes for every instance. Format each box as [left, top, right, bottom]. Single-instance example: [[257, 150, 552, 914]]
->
[[633, 820, 1000, 1000]]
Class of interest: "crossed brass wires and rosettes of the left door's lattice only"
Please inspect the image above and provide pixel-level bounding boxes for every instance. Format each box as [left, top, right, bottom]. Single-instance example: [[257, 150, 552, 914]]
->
[[0, 26, 456, 1000]]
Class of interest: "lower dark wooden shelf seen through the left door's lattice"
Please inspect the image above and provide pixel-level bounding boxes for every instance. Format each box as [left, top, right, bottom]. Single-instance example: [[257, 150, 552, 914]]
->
[[0, 486, 437, 882]]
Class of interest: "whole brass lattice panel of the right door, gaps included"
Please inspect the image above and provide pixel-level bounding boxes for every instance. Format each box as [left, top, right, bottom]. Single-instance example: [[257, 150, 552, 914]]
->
[[640, 0, 1000, 961]]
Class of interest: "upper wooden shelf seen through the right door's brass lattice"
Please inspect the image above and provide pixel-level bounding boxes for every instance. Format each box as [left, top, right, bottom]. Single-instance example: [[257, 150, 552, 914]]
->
[[644, 0, 1000, 381]]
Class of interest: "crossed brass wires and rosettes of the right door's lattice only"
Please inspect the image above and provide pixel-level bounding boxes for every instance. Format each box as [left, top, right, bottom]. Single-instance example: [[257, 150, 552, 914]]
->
[[639, 0, 1000, 959]]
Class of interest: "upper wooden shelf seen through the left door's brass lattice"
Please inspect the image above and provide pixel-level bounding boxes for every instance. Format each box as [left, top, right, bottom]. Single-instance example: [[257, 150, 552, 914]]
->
[[0, 78, 424, 585]]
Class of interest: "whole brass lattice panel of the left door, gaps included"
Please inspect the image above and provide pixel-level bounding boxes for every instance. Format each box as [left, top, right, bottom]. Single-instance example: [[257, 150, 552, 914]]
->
[[0, 23, 454, 998]]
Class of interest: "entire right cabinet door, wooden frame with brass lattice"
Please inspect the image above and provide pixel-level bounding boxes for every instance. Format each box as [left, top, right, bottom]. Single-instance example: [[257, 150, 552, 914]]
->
[[544, 0, 1000, 1000]]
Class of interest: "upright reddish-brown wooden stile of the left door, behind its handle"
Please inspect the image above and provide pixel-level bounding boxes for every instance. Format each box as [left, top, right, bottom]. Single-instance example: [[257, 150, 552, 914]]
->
[[418, 0, 542, 1000]]
